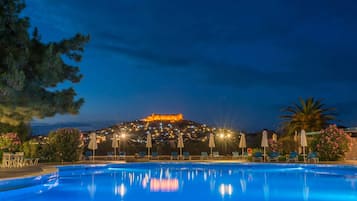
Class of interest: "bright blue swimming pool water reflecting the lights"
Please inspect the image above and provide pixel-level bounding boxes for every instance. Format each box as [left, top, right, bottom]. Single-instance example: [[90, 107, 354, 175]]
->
[[0, 163, 357, 201]]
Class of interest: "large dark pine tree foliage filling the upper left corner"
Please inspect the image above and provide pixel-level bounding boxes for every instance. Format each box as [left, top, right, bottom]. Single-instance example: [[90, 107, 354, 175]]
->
[[0, 0, 89, 125]]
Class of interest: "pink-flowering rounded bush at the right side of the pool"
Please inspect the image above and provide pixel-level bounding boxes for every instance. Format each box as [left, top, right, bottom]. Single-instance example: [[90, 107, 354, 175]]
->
[[316, 125, 352, 161]]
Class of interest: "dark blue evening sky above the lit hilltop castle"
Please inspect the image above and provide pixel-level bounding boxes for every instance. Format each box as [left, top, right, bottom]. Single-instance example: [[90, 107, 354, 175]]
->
[[25, 0, 357, 131]]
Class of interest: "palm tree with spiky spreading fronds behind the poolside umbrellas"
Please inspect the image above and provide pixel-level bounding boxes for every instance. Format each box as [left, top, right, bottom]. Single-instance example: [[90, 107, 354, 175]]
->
[[281, 97, 336, 134]]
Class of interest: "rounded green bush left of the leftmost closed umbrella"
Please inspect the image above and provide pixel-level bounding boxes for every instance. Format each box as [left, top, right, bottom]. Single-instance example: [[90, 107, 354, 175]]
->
[[48, 128, 83, 162]]
